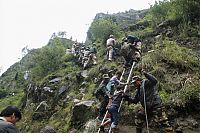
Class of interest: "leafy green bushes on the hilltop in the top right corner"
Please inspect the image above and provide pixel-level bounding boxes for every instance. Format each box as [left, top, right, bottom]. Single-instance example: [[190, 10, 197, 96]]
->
[[150, 0, 200, 24]]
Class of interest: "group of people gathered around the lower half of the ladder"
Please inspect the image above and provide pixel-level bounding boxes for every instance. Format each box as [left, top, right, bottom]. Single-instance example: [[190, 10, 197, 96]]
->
[[97, 71, 173, 133]]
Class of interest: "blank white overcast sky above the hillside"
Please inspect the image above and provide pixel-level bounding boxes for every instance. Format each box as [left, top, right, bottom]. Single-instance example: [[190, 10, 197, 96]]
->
[[0, 0, 155, 75]]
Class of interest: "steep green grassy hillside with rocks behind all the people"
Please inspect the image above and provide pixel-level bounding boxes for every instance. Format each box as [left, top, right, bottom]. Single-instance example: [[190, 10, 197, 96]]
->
[[0, 0, 200, 133]]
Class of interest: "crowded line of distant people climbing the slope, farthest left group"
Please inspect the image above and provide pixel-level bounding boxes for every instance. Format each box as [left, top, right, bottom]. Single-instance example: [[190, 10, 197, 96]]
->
[[71, 41, 97, 69]]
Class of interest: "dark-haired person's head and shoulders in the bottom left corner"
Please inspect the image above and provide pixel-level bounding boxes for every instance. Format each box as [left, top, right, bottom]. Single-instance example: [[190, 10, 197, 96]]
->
[[0, 106, 21, 133]]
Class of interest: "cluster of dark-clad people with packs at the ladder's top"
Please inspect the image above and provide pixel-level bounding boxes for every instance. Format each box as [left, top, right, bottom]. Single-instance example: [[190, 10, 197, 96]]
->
[[120, 35, 141, 67]]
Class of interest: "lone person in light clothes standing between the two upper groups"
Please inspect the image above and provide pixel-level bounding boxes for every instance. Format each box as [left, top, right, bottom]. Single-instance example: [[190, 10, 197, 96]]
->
[[106, 35, 116, 61]]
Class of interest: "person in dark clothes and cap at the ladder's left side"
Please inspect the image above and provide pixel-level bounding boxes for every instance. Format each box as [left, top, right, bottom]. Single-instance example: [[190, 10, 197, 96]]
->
[[95, 74, 110, 120]]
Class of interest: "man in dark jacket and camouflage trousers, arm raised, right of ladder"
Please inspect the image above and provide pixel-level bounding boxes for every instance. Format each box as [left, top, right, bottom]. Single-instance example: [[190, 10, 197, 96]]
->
[[129, 71, 173, 133]]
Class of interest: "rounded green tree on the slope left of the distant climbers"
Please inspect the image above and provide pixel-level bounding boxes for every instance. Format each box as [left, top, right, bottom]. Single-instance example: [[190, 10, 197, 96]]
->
[[32, 39, 65, 78]]
